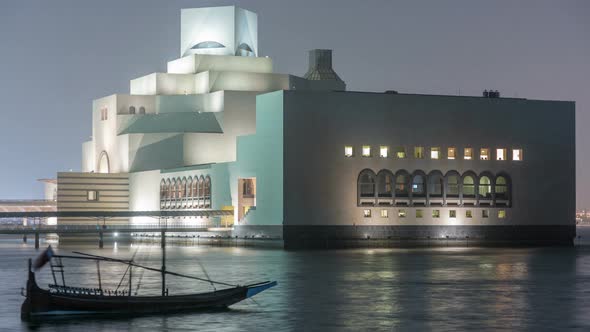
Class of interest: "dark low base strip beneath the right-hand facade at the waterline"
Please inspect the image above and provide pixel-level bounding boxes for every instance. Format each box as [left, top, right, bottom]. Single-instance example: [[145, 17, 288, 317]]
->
[[283, 225, 576, 249]]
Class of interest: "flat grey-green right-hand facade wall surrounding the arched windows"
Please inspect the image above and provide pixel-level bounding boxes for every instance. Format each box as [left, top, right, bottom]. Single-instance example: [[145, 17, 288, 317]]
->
[[284, 91, 575, 246]]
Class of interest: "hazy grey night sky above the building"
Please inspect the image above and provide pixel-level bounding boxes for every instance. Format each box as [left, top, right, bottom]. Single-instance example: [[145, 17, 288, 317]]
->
[[0, 0, 590, 208]]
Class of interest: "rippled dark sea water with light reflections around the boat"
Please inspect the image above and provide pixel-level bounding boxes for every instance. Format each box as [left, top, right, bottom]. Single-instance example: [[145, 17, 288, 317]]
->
[[0, 228, 590, 332]]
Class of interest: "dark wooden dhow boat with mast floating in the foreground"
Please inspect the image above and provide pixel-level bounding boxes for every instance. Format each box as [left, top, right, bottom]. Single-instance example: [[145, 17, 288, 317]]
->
[[21, 247, 277, 321]]
